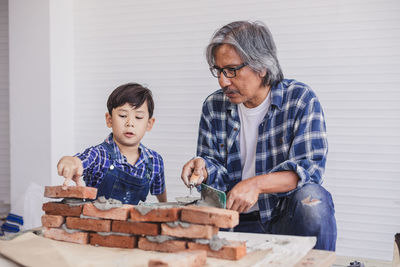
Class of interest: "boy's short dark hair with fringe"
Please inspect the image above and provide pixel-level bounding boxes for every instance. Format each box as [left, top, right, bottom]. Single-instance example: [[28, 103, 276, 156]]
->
[[107, 83, 154, 118]]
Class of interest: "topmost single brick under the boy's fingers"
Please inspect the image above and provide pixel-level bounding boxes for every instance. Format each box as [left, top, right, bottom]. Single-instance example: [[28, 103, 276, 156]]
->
[[44, 185, 97, 199]]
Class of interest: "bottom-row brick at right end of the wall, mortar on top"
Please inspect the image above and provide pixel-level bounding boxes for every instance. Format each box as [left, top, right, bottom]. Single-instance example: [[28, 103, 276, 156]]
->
[[188, 241, 246, 260]]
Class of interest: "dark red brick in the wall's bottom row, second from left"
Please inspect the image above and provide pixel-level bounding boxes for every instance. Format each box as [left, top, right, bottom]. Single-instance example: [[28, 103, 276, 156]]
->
[[89, 233, 137, 248]]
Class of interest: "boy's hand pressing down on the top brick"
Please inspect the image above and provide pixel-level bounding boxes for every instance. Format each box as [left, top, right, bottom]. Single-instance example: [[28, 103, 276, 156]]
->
[[57, 156, 85, 189]]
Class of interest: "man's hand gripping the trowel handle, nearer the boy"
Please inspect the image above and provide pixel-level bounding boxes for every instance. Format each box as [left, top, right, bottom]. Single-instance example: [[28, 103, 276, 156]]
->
[[181, 157, 208, 187]]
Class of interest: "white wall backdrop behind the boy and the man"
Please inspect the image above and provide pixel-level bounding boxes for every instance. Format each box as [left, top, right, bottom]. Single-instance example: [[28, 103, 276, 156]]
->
[[6, 0, 400, 260]]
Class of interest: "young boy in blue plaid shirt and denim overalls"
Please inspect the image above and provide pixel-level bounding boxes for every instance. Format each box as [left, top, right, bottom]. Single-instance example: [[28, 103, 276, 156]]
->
[[57, 83, 167, 205]]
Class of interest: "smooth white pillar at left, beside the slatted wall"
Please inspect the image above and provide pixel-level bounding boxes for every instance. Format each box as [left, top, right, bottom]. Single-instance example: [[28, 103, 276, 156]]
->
[[9, 0, 74, 228]]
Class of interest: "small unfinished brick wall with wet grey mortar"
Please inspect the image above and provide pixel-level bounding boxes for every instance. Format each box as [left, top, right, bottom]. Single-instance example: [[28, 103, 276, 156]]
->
[[42, 186, 246, 260]]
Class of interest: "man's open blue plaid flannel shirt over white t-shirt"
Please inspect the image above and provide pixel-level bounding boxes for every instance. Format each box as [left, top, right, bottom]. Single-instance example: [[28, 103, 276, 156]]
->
[[197, 79, 328, 222]]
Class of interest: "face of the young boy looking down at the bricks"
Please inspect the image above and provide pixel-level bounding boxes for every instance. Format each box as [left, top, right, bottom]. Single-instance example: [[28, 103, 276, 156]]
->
[[106, 101, 154, 150]]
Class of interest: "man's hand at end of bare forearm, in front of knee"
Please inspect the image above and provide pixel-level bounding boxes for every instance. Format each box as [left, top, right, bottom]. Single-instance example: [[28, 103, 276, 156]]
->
[[226, 177, 260, 213]]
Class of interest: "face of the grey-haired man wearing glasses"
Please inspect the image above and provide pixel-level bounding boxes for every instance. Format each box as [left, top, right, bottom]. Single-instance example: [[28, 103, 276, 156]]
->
[[215, 44, 269, 108]]
